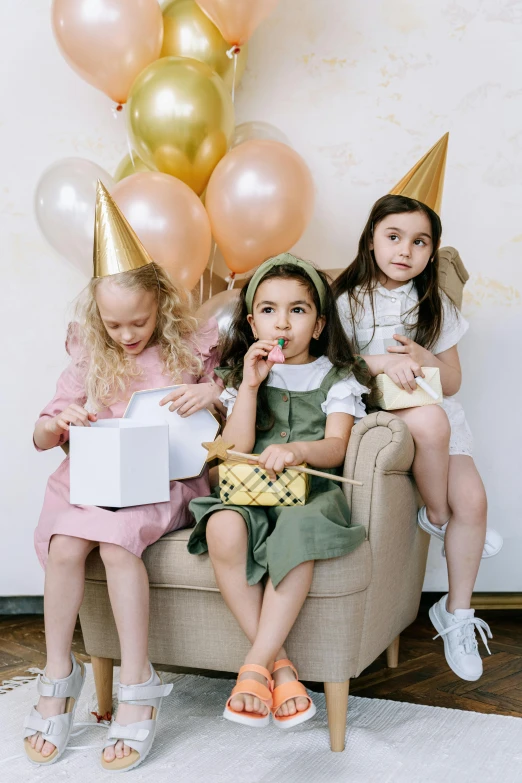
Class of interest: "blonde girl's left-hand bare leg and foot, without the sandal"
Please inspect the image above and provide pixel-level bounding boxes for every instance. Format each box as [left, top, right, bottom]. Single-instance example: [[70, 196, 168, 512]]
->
[[29, 535, 97, 756]]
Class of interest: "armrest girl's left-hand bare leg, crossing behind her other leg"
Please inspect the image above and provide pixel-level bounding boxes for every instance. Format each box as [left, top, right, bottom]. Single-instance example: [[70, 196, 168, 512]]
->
[[394, 405, 451, 527]]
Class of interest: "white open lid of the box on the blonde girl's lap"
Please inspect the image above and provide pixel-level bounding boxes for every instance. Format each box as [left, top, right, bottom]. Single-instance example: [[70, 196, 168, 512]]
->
[[123, 386, 219, 481]]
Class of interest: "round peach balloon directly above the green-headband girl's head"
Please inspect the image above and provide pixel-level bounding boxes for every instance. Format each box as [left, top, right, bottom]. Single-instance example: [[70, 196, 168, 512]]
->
[[205, 139, 314, 273]]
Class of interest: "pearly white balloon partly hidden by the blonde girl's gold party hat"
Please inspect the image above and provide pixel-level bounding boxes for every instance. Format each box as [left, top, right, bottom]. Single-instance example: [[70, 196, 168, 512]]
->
[[34, 158, 114, 277]]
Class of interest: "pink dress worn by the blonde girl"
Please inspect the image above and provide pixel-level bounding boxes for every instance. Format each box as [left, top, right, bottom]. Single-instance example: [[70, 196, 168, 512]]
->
[[35, 319, 222, 568]]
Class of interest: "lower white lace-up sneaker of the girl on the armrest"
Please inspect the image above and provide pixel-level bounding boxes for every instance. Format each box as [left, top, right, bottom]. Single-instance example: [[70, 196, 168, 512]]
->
[[430, 595, 493, 682]]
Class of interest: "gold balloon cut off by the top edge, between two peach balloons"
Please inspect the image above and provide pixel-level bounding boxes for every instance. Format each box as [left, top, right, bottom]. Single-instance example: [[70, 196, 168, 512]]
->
[[161, 0, 247, 90]]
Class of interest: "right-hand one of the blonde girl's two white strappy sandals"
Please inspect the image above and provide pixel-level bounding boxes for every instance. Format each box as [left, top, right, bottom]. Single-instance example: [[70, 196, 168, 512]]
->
[[101, 664, 172, 772]]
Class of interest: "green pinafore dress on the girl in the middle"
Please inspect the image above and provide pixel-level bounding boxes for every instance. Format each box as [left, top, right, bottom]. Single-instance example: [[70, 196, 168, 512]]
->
[[188, 367, 366, 587]]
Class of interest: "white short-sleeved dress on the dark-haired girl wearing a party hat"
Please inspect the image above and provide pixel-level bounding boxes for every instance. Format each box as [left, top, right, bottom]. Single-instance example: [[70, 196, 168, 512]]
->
[[337, 281, 473, 457]]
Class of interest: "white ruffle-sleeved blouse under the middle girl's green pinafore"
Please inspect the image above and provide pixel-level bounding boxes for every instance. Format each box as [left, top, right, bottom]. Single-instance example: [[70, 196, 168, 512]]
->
[[219, 356, 369, 419]]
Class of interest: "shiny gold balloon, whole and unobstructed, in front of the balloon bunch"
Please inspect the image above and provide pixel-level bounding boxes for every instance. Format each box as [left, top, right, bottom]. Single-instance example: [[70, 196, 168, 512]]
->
[[127, 57, 234, 196]]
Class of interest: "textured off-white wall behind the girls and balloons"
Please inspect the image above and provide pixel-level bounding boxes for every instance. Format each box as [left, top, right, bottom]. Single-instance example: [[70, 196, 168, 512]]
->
[[0, 0, 522, 595]]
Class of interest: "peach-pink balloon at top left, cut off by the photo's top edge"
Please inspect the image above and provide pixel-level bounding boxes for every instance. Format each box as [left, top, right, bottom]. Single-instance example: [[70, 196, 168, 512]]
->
[[52, 0, 163, 103]]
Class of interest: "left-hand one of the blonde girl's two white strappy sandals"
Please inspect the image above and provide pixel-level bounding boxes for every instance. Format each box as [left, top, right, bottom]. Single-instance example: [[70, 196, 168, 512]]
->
[[24, 653, 85, 766]]
